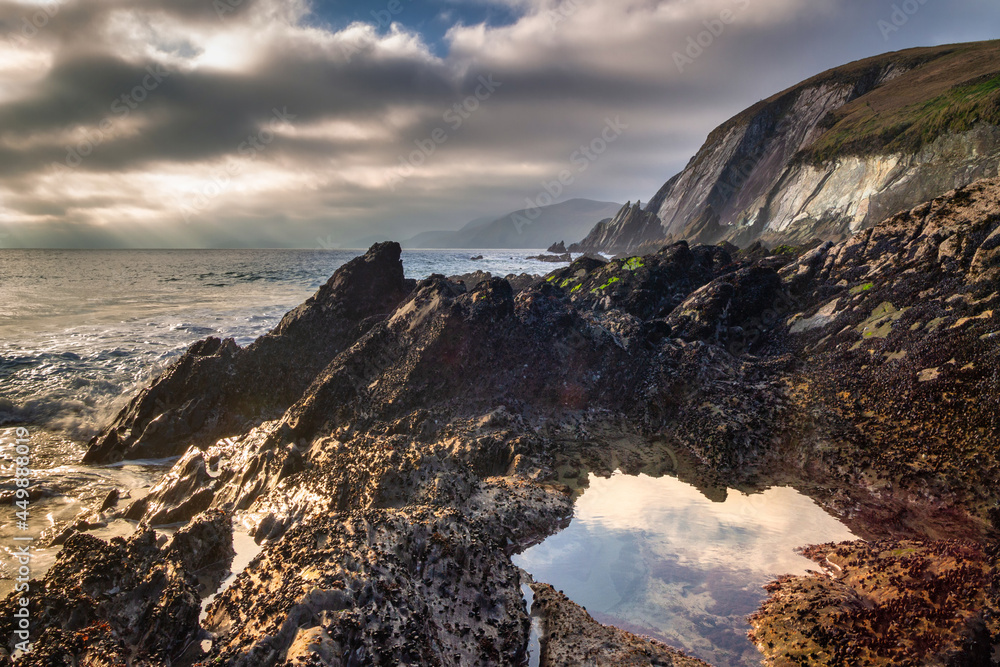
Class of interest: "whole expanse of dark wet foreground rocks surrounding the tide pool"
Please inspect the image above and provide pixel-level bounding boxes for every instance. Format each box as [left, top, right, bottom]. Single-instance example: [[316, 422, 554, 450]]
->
[[19, 181, 1000, 665]]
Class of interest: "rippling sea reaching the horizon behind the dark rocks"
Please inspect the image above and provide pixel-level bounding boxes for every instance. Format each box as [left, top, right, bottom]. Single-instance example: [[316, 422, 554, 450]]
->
[[0, 249, 556, 441]]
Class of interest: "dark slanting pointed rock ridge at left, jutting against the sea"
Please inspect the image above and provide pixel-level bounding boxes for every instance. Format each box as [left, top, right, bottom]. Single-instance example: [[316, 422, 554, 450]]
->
[[84, 243, 411, 463]]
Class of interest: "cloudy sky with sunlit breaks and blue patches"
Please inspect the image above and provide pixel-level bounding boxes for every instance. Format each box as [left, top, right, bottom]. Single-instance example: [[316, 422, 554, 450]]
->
[[0, 0, 1000, 248]]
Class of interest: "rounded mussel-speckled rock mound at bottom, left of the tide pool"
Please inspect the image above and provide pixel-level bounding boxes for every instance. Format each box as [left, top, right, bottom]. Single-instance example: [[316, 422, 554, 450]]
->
[[206, 506, 572, 666]]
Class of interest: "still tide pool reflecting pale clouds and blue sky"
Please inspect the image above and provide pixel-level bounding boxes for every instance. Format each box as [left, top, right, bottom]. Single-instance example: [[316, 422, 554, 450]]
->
[[514, 473, 857, 667]]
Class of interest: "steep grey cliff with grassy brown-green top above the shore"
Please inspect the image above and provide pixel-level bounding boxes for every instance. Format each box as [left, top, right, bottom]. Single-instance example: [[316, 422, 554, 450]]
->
[[580, 42, 1000, 252]]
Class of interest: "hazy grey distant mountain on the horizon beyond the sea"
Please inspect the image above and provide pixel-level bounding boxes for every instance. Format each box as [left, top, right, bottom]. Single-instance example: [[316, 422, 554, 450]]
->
[[403, 199, 621, 249]]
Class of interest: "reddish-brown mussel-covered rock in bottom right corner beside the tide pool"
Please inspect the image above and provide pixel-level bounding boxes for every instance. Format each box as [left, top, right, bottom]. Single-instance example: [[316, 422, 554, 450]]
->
[[751, 541, 1000, 666]]
